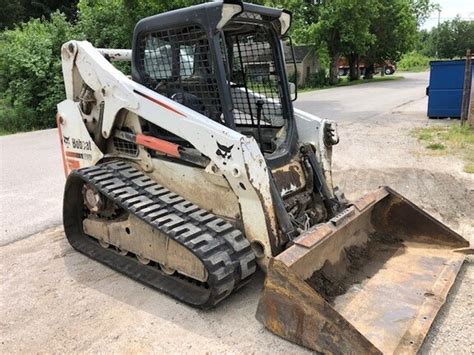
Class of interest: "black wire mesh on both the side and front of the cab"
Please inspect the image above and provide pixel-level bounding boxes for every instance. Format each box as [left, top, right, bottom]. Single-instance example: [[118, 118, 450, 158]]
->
[[138, 24, 284, 127]]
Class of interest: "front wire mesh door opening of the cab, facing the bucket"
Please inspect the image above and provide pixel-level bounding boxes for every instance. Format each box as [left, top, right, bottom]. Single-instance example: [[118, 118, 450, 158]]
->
[[227, 26, 284, 127]]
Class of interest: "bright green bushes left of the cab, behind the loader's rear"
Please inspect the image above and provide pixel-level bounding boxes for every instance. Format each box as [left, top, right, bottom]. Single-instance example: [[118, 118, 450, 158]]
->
[[0, 0, 204, 132]]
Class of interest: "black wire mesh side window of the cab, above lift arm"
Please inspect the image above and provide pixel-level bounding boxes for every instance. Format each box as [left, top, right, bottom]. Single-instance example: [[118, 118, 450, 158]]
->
[[139, 25, 223, 122]]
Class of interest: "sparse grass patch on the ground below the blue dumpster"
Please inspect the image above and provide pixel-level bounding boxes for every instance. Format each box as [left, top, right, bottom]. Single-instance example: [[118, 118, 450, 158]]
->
[[413, 122, 474, 174]]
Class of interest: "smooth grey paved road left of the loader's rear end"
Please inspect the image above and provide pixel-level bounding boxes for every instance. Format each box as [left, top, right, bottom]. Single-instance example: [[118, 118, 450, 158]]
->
[[0, 129, 65, 245]]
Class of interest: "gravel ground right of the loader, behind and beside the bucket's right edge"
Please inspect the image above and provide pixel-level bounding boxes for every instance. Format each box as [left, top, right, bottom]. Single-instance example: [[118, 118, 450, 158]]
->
[[334, 100, 474, 354]]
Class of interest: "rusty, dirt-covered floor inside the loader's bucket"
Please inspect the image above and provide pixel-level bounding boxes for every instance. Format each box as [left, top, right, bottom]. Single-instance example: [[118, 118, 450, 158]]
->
[[306, 227, 464, 353]]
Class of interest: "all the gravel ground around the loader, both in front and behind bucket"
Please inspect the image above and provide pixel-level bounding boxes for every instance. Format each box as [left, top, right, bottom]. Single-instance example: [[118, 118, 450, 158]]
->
[[0, 74, 474, 354]]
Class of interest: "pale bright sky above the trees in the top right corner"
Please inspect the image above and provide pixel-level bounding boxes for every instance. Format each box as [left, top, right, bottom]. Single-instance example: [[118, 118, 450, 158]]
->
[[421, 0, 474, 30]]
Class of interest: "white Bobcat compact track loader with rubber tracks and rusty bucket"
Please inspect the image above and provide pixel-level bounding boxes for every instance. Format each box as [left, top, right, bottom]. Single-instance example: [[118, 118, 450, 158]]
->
[[57, 1, 468, 353]]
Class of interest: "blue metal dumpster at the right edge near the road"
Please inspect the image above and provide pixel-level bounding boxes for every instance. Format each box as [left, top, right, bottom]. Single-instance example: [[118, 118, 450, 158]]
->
[[427, 59, 472, 118]]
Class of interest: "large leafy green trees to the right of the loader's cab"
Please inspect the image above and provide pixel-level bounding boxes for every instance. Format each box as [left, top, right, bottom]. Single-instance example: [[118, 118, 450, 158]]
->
[[266, 0, 422, 84]]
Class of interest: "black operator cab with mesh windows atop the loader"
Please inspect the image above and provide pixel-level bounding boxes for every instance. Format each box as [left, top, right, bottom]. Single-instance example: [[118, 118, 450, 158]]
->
[[132, 1, 297, 165]]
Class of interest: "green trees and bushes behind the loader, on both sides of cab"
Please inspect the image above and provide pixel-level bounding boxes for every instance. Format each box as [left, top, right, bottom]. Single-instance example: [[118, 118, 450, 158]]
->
[[0, 0, 472, 132]]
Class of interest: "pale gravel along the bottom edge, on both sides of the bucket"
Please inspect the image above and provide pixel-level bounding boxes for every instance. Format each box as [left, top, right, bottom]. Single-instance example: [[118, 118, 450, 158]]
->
[[0, 227, 468, 354]]
